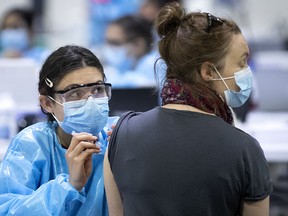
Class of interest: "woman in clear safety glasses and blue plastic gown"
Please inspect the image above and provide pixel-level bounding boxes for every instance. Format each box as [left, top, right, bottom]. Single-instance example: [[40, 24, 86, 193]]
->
[[0, 45, 117, 216]]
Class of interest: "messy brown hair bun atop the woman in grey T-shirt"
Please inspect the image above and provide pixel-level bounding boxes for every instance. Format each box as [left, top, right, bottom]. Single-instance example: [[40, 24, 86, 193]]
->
[[155, 2, 186, 37]]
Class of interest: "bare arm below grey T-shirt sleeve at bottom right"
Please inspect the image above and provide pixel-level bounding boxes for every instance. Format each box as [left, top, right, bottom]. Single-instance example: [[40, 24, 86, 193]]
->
[[242, 196, 269, 216]]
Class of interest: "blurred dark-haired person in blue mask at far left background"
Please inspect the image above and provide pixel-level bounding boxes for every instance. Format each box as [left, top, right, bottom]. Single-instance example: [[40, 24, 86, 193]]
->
[[0, 8, 49, 63]]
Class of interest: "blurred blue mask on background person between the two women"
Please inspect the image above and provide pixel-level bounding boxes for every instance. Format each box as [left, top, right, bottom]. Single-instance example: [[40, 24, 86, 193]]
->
[[103, 45, 134, 73]]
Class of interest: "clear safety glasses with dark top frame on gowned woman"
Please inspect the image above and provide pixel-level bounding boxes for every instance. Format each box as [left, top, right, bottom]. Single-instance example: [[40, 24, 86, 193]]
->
[[54, 83, 112, 102]]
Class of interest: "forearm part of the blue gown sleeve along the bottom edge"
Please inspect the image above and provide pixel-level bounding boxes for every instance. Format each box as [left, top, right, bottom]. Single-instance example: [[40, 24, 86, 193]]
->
[[0, 168, 85, 216]]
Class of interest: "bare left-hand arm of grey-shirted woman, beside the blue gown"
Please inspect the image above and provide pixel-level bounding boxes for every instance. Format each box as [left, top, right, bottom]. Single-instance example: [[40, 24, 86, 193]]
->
[[104, 150, 123, 216]]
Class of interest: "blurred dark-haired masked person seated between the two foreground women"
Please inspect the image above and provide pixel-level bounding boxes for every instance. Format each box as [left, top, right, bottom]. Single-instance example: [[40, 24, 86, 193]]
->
[[101, 15, 164, 87]]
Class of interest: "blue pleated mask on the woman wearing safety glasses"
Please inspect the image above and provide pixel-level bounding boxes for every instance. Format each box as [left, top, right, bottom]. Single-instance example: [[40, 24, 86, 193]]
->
[[53, 97, 109, 135]]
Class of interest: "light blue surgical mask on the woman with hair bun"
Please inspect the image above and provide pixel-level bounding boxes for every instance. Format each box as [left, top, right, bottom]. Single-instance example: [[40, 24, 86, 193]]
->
[[212, 65, 253, 108]]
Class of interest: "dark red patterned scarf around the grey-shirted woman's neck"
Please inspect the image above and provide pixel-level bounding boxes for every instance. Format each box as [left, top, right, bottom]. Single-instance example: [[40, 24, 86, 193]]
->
[[161, 79, 233, 124]]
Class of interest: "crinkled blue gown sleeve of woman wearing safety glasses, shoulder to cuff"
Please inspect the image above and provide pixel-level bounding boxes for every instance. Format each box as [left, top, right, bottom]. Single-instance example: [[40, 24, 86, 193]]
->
[[0, 134, 86, 216]]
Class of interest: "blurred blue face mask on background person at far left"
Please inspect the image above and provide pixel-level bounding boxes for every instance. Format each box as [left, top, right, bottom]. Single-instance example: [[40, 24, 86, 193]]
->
[[0, 28, 29, 52]]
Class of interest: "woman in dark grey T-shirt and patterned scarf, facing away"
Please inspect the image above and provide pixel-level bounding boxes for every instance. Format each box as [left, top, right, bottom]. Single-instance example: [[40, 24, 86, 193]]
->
[[104, 4, 272, 216]]
